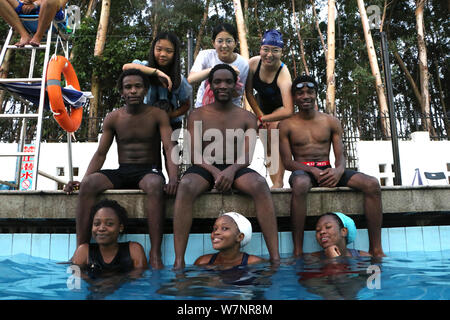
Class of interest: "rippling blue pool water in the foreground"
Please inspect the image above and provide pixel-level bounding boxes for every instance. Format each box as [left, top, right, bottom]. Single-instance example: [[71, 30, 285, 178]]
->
[[0, 250, 450, 300]]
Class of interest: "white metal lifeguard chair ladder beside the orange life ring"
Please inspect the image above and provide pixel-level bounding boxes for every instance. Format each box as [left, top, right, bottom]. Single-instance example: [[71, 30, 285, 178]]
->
[[0, 6, 79, 190]]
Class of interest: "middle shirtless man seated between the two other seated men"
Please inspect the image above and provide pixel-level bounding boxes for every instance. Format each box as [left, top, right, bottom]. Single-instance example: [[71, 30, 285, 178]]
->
[[173, 64, 280, 269]]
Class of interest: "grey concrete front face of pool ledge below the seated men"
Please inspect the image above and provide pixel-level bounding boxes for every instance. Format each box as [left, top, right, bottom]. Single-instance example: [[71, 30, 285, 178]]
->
[[0, 186, 450, 220]]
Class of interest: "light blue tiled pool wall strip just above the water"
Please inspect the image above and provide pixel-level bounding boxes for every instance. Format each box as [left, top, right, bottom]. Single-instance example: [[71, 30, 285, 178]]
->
[[0, 226, 450, 265]]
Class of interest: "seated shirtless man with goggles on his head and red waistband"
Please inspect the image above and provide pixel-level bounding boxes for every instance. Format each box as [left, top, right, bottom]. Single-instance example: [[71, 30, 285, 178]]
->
[[278, 76, 384, 256]]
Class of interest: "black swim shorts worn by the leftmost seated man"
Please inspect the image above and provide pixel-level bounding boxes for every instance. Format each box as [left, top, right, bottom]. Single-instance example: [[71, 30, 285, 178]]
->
[[99, 164, 166, 189]]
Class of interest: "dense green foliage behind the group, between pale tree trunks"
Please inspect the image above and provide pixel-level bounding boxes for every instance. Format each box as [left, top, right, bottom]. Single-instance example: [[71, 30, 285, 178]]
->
[[0, 0, 450, 141]]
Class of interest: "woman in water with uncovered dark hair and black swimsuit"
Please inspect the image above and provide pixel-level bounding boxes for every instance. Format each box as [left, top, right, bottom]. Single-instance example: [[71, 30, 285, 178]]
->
[[72, 199, 147, 276]]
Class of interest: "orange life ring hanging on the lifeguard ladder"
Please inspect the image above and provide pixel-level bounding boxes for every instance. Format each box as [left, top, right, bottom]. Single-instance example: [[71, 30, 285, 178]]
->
[[45, 56, 83, 132]]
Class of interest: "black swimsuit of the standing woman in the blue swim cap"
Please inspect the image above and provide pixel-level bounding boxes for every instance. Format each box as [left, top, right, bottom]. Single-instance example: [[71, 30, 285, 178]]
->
[[253, 60, 284, 114]]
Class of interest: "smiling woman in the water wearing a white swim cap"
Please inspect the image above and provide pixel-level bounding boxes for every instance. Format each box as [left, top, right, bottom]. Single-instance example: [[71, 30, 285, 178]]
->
[[194, 212, 264, 269]]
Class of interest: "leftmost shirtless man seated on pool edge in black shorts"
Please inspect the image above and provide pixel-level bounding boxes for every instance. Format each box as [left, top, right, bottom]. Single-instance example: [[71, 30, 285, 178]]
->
[[64, 69, 178, 268]]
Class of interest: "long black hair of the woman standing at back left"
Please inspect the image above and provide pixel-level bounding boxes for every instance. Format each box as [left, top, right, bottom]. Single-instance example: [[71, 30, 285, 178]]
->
[[148, 31, 181, 89]]
